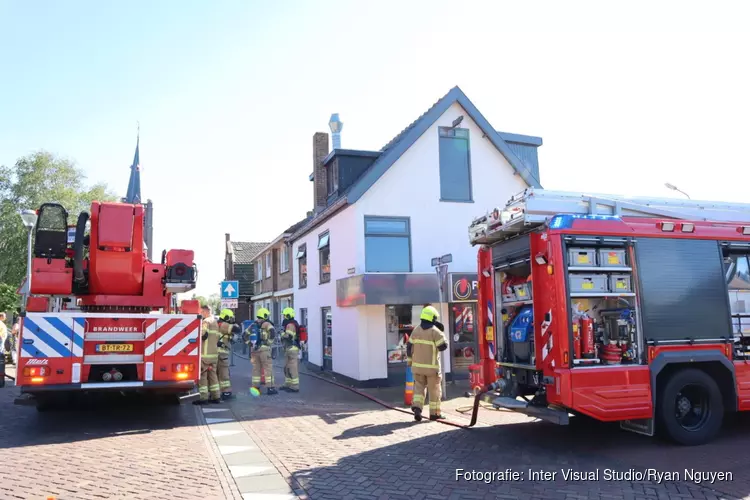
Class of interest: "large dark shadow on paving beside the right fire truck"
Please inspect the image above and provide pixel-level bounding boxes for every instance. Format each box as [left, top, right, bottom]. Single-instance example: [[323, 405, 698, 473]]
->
[[293, 419, 750, 500]]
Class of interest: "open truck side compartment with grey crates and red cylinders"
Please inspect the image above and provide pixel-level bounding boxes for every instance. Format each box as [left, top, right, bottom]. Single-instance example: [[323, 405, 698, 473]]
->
[[563, 235, 645, 368]]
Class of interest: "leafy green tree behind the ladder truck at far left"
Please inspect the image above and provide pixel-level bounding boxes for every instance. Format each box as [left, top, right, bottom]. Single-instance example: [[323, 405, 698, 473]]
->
[[0, 151, 117, 292]]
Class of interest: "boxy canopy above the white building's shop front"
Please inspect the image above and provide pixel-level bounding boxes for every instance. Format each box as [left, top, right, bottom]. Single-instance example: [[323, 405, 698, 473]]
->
[[336, 273, 440, 307]]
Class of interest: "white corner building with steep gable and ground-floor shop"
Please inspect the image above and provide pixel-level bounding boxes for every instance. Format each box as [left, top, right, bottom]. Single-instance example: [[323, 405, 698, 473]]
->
[[289, 87, 542, 386]]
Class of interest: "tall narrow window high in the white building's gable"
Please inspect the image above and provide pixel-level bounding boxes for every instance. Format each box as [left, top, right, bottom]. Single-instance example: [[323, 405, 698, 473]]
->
[[439, 127, 472, 202]]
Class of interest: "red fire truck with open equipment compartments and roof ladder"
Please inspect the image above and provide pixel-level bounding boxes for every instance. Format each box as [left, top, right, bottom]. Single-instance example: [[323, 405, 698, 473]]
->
[[469, 188, 750, 445]]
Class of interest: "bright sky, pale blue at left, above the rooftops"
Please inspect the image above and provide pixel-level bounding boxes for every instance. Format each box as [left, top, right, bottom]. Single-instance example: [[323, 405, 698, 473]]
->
[[0, 0, 750, 294]]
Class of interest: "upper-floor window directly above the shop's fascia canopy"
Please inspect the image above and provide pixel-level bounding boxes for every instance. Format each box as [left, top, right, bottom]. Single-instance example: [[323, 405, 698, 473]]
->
[[365, 217, 411, 273]]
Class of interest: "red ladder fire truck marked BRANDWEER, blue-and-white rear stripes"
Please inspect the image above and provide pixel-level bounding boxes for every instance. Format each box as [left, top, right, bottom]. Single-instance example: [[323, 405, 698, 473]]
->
[[16, 201, 201, 410]]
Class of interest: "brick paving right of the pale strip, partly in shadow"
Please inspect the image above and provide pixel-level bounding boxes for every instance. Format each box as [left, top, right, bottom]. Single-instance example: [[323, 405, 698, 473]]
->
[[225, 354, 750, 500]]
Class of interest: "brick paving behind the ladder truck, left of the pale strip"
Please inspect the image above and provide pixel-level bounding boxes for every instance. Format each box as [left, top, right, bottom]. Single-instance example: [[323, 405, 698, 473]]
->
[[0, 368, 241, 500]]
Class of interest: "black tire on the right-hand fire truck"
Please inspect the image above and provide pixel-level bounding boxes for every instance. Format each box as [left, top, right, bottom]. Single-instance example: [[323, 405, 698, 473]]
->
[[656, 368, 724, 446]]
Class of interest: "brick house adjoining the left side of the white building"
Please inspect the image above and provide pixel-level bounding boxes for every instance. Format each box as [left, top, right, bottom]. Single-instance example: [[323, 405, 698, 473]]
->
[[250, 214, 312, 325]]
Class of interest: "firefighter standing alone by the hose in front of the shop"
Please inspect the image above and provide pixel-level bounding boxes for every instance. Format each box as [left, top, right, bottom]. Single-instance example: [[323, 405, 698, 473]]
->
[[406, 305, 448, 422]]
